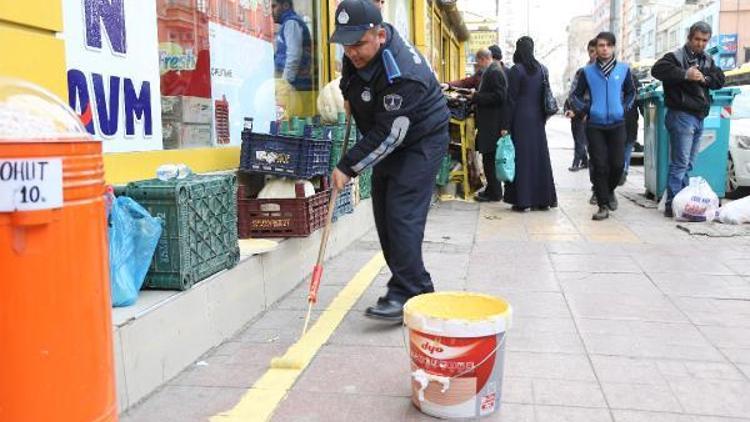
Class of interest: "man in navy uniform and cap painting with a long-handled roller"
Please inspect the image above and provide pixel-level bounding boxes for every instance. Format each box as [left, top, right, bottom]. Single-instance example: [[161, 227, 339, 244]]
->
[[330, 0, 450, 321]]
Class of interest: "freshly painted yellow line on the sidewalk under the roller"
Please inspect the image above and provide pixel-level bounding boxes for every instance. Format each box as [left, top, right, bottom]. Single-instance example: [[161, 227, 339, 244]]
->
[[211, 253, 385, 422]]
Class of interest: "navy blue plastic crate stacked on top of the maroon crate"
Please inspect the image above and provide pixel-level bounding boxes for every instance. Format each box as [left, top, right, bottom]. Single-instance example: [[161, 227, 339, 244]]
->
[[240, 130, 331, 179]]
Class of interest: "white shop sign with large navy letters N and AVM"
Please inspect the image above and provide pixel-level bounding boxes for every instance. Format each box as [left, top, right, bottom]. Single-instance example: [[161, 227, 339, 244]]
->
[[63, 0, 164, 152]]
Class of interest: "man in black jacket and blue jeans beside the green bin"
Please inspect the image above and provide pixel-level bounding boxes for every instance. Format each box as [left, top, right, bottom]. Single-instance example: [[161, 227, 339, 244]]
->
[[651, 22, 724, 217]]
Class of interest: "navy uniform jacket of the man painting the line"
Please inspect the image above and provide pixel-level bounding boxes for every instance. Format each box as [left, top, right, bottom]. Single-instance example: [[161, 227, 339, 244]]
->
[[338, 23, 450, 176]]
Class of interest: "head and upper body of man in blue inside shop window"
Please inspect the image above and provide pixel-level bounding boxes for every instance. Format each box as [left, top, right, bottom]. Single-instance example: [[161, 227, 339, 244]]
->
[[272, 0, 312, 91]]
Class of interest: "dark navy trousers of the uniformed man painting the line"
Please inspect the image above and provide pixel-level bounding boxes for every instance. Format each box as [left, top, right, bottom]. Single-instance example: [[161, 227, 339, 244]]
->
[[372, 134, 448, 303]]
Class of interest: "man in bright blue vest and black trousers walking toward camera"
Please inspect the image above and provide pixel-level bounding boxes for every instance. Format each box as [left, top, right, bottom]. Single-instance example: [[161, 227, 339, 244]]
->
[[569, 32, 635, 221]]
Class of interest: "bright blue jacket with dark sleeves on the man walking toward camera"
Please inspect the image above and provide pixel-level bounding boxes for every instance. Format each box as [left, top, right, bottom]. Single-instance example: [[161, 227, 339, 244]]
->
[[568, 63, 636, 128]]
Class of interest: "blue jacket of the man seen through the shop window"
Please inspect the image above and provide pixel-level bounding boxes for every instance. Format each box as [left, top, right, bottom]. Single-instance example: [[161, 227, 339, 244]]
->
[[273, 10, 312, 91]]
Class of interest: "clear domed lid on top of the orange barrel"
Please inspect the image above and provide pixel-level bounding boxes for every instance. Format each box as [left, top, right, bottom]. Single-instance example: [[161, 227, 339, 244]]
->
[[0, 77, 94, 143]]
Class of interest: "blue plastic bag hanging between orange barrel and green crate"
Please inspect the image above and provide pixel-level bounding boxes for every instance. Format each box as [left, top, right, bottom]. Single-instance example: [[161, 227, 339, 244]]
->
[[109, 196, 162, 306]]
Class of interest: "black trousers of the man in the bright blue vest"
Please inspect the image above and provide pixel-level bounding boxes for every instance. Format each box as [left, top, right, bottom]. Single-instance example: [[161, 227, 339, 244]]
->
[[586, 125, 626, 205]]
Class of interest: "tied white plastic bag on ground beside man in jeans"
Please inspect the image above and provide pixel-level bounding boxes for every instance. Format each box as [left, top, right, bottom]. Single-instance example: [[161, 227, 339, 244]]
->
[[672, 177, 719, 222]]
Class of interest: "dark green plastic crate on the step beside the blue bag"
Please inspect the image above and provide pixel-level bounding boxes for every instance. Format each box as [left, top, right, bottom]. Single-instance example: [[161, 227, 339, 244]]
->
[[124, 174, 240, 290]]
